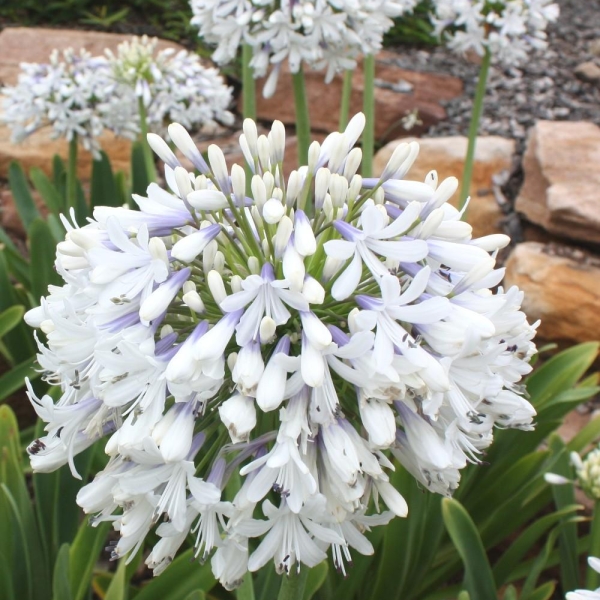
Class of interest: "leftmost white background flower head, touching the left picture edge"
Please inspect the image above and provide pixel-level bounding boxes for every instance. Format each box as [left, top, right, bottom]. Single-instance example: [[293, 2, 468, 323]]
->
[[2, 49, 135, 155]]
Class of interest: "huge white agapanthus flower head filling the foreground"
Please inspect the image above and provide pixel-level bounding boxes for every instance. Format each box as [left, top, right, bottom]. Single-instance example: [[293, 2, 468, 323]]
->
[[26, 114, 535, 589]]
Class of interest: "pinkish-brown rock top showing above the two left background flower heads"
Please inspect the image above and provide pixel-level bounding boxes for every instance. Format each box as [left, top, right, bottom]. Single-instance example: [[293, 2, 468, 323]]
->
[[0, 27, 183, 85]]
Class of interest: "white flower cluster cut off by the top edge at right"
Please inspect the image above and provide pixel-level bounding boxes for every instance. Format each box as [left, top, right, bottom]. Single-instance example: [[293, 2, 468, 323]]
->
[[432, 0, 559, 64]]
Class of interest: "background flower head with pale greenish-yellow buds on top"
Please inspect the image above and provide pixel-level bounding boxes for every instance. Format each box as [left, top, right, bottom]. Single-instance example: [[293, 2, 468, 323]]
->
[[106, 36, 233, 132]]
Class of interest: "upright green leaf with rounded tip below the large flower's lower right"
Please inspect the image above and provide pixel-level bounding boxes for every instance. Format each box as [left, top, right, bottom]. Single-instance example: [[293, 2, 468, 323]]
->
[[442, 498, 497, 600]]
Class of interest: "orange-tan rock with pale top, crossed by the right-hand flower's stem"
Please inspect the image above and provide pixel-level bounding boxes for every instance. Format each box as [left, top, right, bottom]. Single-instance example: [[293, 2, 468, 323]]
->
[[373, 136, 515, 237]]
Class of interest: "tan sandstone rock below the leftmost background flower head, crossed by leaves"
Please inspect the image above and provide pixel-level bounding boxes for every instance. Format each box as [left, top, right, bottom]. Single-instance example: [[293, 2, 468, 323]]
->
[[0, 120, 131, 179]]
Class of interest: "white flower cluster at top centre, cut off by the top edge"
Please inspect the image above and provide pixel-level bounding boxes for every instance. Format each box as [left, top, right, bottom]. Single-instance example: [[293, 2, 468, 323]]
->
[[191, 0, 417, 97]]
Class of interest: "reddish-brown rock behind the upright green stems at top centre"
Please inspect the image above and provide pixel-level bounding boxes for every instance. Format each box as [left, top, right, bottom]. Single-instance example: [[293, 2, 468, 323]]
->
[[248, 52, 463, 141]]
